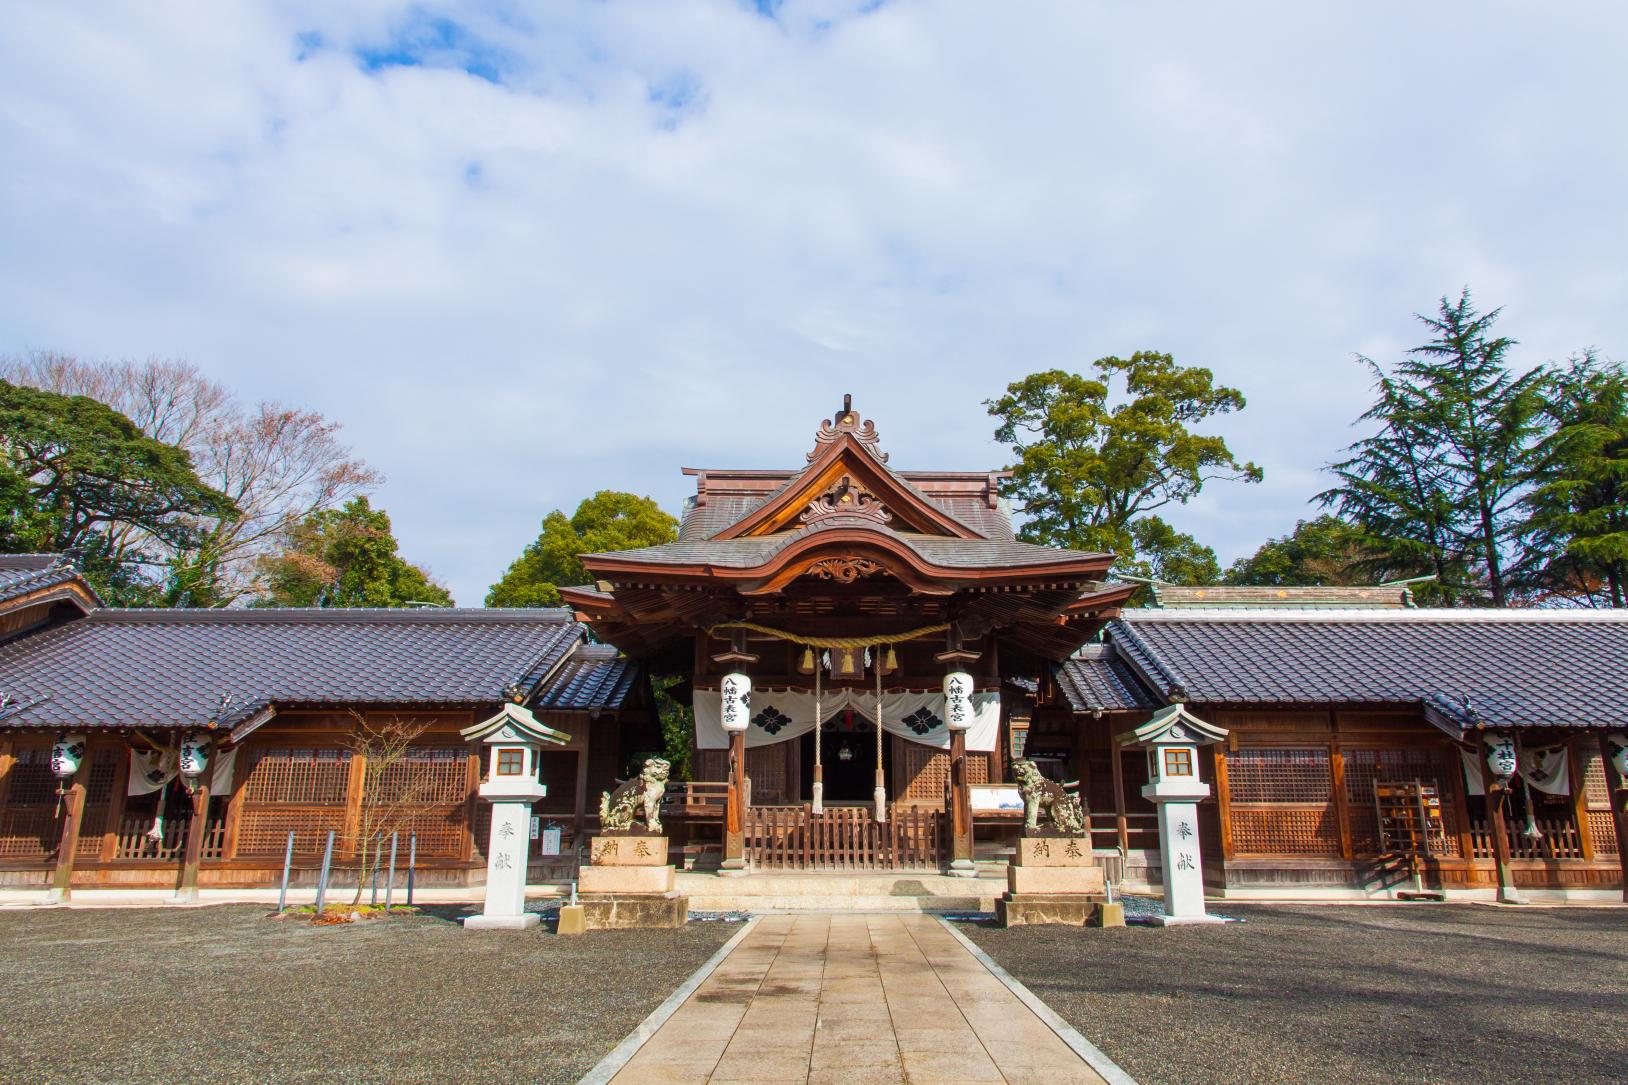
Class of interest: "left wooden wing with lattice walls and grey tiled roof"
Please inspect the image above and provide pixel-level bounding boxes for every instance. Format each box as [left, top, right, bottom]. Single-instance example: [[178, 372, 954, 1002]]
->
[[0, 570, 661, 893]]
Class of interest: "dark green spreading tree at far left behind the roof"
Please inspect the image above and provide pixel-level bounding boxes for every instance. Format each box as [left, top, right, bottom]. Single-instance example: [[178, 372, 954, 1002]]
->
[[0, 381, 238, 604]]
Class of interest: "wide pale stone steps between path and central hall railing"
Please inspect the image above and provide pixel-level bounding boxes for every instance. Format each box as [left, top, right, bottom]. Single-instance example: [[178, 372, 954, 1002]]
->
[[677, 863, 1006, 914]]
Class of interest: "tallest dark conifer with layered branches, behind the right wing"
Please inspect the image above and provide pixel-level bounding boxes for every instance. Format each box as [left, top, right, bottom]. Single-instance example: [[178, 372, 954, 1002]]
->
[[1317, 290, 1548, 606]]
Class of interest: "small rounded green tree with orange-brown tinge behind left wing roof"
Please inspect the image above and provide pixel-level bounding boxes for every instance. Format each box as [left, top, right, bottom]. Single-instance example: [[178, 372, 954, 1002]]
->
[[259, 497, 453, 608]]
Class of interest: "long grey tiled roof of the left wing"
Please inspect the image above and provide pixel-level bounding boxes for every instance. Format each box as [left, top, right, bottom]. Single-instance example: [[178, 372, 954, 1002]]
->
[[0, 609, 583, 727]]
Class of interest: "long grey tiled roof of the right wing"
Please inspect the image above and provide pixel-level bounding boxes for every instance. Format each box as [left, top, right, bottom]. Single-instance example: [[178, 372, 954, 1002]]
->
[[1109, 609, 1628, 727]]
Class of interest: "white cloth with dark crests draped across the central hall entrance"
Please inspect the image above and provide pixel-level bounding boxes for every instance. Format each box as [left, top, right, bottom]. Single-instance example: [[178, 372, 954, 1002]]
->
[[695, 689, 1001, 753]]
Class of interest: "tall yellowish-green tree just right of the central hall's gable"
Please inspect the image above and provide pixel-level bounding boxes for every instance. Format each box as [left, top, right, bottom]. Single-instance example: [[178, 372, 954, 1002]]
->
[[983, 350, 1262, 575]]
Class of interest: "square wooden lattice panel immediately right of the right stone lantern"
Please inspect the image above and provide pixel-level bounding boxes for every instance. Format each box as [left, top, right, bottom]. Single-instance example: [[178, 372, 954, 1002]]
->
[[1226, 748, 1340, 855]]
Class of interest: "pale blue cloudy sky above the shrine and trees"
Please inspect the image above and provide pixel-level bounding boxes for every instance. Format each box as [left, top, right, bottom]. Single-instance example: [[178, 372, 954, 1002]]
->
[[0, 0, 1628, 603]]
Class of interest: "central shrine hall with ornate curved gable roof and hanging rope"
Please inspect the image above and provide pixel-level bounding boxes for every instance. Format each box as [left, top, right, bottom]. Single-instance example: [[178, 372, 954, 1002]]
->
[[563, 399, 1135, 868]]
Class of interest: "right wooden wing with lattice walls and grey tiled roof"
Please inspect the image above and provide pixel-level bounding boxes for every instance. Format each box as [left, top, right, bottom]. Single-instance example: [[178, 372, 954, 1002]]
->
[[1048, 608, 1628, 899]]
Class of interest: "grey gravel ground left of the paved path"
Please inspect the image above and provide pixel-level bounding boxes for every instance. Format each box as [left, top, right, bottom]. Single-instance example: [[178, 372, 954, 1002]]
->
[[0, 906, 741, 1085]]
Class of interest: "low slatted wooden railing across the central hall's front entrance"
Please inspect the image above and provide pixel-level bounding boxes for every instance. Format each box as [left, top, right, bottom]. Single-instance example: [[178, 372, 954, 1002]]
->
[[744, 805, 949, 870]]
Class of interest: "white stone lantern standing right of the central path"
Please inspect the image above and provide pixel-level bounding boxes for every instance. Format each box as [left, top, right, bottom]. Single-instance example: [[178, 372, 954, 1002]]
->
[[1118, 704, 1226, 927]]
